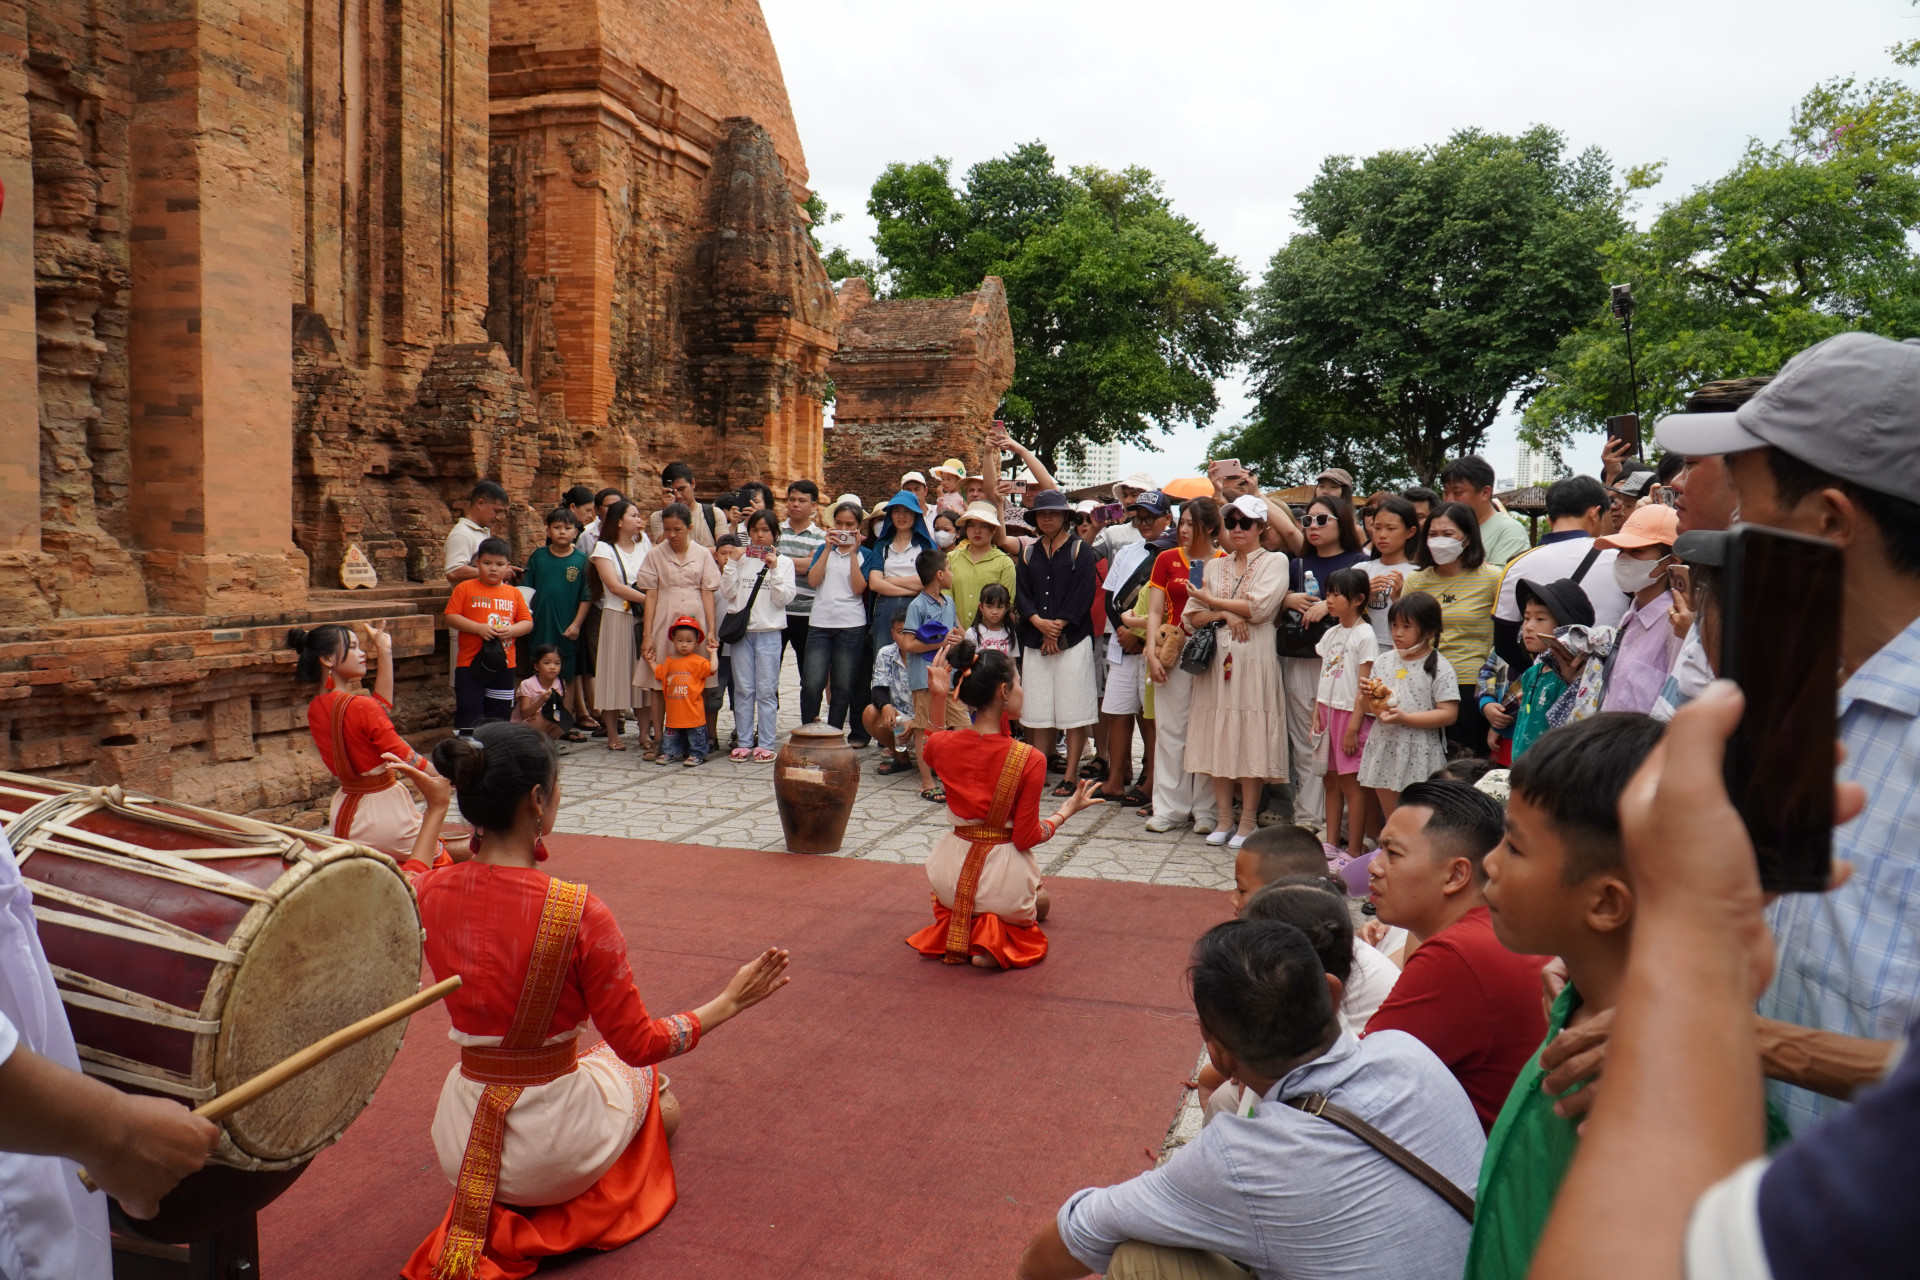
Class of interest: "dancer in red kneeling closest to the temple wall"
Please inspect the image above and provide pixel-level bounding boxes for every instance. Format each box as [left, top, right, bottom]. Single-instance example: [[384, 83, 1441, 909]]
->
[[286, 622, 434, 862]]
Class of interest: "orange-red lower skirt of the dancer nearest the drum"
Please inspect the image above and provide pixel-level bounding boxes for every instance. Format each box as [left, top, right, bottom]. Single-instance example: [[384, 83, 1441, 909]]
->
[[399, 1071, 680, 1280]]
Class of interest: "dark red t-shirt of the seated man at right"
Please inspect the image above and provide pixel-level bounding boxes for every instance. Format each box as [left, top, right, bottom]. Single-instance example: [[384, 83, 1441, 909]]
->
[[1367, 906, 1548, 1130]]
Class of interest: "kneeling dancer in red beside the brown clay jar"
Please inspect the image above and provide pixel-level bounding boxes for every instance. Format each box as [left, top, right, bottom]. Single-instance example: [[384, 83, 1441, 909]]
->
[[906, 639, 1100, 969]]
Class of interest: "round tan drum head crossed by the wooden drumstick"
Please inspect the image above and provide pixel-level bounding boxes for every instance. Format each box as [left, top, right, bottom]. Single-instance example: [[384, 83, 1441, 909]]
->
[[213, 856, 420, 1163]]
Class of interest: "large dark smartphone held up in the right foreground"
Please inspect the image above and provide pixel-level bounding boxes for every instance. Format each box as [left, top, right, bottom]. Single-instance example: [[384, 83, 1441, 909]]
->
[[1720, 524, 1841, 892]]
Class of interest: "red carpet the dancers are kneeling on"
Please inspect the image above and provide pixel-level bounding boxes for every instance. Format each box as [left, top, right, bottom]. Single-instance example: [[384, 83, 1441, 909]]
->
[[259, 837, 1231, 1280]]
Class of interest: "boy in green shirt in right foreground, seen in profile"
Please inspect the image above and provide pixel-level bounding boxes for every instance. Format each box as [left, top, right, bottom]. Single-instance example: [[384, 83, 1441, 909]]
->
[[1467, 712, 1784, 1280]]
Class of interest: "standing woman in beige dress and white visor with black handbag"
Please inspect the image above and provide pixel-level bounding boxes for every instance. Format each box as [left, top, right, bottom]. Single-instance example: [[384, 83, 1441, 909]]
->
[[1185, 493, 1286, 848]]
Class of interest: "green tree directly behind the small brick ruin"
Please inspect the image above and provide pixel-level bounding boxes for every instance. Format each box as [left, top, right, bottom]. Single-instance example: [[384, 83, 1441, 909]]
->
[[860, 142, 1246, 464]]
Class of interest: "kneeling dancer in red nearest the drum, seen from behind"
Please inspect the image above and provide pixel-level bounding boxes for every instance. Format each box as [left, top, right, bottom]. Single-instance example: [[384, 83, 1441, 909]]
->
[[394, 722, 787, 1280]]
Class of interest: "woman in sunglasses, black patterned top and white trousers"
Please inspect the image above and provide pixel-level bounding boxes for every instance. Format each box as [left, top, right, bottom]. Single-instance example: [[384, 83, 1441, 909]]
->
[[1279, 495, 1367, 842]]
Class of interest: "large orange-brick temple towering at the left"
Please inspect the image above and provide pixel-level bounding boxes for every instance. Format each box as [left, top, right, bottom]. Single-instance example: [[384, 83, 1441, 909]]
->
[[0, 0, 837, 818]]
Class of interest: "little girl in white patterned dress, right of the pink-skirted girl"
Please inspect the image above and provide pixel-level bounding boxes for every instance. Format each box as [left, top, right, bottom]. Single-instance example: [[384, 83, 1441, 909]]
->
[[1359, 591, 1459, 819]]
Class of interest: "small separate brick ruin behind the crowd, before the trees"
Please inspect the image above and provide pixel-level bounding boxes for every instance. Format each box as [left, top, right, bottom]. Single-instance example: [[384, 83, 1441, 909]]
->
[[826, 276, 1014, 503]]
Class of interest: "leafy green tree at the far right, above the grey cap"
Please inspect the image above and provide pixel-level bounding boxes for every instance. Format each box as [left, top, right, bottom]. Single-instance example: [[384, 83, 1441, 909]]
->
[[1523, 71, 1920, 447]]
